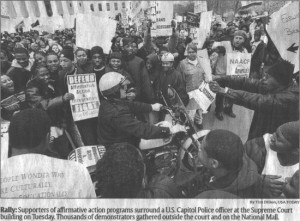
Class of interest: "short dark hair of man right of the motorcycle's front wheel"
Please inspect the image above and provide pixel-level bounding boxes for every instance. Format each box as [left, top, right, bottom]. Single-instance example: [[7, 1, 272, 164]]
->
[[205, 130, 244, 170]]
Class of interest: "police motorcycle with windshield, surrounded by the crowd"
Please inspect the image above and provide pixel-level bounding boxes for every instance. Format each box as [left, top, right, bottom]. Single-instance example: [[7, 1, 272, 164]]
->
[[139, 87, 210, 197]]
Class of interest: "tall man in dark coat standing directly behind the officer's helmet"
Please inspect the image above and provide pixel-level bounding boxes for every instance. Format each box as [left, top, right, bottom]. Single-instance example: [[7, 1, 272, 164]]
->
[[122, 37, 154, 103]]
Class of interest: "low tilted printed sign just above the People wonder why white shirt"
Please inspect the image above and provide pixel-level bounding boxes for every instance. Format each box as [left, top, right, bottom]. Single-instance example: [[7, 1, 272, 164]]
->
[[68, 146, 105, 173]]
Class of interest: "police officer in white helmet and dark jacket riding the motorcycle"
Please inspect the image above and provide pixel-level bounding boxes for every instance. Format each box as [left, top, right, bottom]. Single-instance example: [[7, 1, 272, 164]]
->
[[97, 72, 171, 147]]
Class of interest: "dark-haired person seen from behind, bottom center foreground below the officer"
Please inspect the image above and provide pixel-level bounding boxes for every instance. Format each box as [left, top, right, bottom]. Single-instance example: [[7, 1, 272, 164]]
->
[[96, 143, 182, 198]]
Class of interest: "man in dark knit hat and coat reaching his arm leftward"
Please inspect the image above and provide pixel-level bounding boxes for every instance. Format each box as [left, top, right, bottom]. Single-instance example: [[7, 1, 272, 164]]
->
[[210, 61, 299, 140]]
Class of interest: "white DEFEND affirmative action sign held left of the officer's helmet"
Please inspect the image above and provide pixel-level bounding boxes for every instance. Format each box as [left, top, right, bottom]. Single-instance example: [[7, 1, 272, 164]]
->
[[67, 74, 100, 121]]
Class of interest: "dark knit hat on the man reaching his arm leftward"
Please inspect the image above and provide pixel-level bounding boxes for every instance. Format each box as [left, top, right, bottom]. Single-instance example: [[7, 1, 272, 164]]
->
[[268, 60, 294, 86]]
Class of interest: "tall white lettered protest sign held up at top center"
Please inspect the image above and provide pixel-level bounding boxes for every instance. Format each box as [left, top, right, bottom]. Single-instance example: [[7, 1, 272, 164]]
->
[[151, 1, 174, 37]]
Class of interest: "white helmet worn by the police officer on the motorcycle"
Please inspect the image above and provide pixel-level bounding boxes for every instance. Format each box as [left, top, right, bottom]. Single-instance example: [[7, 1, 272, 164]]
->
[[99, 72, 126, 97]]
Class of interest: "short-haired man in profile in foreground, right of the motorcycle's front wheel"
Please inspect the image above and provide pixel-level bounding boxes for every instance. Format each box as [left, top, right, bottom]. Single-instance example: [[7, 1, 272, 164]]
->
[[197, 130, 263, 198]]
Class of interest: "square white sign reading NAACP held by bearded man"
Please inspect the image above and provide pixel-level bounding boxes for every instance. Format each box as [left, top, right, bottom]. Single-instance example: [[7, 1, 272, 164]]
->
[[226, 52, 251, 77]]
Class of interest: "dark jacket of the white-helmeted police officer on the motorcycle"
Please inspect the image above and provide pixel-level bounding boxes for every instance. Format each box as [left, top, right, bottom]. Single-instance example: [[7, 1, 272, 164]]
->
[[97, 100, 169, 145]]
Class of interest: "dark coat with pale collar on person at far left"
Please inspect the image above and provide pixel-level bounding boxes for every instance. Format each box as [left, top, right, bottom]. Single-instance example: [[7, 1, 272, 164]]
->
[[6, 60, 33, 93]]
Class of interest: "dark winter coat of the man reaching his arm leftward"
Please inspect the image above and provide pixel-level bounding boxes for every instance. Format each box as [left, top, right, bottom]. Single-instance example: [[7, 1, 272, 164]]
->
[[217, 76, 299, 140]]
